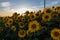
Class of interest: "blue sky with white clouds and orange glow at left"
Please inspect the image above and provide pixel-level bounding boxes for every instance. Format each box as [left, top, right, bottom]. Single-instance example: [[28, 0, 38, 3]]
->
[[0, 0, 60, 16]]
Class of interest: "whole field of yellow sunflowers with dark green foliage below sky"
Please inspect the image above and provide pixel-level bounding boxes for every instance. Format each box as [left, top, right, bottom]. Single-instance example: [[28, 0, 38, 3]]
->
[[0, 6, 60, 40]]
